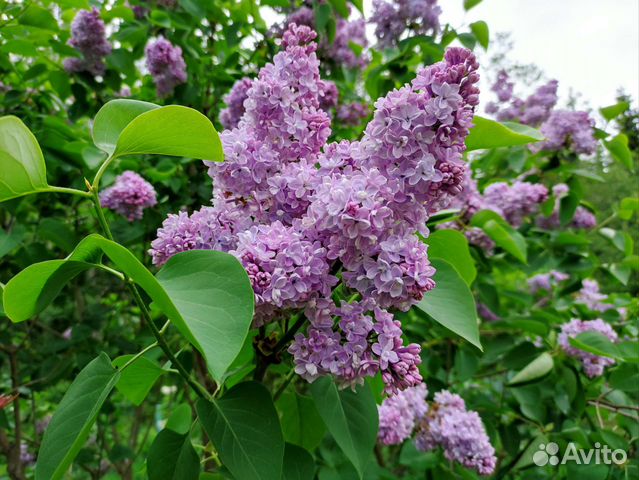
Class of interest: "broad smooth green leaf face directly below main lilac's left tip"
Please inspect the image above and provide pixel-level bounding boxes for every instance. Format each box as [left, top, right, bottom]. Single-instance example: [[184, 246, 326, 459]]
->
[[157, 250, 254, 380]]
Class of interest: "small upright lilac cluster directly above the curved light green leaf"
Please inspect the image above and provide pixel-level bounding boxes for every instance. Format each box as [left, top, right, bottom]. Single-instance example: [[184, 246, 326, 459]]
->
[[145, 38, 187, 97]]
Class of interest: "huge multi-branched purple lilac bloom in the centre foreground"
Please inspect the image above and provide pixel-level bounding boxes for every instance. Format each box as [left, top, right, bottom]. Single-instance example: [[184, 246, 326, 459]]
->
[[150, 24, 478, 393]]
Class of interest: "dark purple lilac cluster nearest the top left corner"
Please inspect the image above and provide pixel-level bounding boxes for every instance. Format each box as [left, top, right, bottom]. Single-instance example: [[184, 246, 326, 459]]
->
[[64, 8, 111, 76]]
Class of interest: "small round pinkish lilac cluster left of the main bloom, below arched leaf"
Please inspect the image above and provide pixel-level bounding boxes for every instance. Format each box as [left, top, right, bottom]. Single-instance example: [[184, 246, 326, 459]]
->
[[100, 171, 157, 222]]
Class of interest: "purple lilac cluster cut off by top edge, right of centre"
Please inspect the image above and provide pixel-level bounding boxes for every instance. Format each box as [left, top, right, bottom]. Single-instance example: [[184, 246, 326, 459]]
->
[[370, 0, 442, 46]]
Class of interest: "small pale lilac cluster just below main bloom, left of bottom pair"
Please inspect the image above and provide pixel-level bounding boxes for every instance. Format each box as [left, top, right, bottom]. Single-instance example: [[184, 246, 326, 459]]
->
[[377, 383, 428, 445]]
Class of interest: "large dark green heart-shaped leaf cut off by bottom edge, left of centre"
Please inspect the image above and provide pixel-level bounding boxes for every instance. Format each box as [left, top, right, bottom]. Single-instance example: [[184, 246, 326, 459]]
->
[[196, 382, 284, 480]]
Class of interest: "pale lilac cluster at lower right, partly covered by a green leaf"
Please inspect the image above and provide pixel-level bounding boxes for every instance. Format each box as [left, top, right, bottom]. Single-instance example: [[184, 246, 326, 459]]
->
[[559, 318, 618, 378]]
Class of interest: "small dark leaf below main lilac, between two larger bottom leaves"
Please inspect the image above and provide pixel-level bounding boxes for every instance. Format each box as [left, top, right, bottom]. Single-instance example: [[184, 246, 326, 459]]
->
[[276, 392, 326, 451]]
